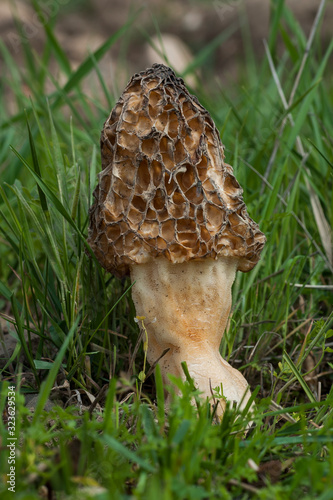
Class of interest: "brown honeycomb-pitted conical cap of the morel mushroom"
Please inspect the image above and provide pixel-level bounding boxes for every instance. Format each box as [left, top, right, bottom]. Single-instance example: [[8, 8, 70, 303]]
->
[[88, 64, 266, 277]]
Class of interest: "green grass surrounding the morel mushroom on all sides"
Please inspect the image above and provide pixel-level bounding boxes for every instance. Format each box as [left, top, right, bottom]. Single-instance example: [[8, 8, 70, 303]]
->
[[0, 0, 333, 500]]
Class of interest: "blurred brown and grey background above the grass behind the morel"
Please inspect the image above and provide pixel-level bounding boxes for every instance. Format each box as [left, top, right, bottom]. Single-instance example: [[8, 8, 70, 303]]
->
[[0, 0, 333, 106]]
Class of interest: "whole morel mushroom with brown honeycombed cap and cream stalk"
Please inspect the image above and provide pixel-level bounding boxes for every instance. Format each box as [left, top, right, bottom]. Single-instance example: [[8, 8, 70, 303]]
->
[[89, 64, 265, 415]]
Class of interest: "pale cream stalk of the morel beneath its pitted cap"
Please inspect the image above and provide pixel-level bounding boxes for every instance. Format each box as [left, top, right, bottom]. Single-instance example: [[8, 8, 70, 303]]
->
[[131, 257, 250, 416]]
